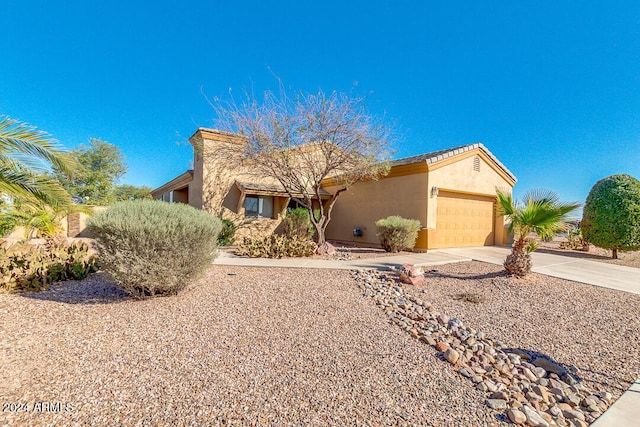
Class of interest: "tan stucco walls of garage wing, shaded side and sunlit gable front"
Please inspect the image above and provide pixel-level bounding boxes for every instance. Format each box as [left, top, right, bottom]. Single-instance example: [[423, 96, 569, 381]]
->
[[327, 149, 513, 249]]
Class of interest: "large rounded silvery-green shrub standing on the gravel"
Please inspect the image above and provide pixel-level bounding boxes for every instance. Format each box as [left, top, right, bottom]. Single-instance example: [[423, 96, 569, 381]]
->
[[89, 200, 221, 298]]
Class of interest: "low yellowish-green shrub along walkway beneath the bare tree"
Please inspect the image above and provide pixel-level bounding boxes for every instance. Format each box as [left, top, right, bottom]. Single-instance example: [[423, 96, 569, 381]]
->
[[236, 234, 317, 258]]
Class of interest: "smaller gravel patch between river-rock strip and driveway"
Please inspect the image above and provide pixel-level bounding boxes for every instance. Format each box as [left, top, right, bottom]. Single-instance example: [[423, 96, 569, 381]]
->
[[413, 262, 640, 398]]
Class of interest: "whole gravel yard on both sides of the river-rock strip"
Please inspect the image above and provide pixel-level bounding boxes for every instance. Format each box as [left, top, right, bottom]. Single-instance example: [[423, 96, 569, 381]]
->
[[0, 263, 640, 426]]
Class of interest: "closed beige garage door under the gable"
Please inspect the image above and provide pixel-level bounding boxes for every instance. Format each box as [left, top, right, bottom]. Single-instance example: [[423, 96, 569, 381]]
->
[[429, 191, 495, 248]]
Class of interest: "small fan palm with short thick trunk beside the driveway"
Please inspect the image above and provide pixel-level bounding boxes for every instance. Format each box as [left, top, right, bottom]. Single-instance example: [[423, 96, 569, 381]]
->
[[497, 190, 580, 277]]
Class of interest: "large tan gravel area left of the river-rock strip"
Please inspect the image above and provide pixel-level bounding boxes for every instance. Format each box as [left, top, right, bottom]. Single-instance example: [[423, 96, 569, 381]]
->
[[0, 266, 501, 426]]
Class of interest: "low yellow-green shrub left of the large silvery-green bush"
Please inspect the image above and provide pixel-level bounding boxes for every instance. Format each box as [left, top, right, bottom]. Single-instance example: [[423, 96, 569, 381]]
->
[[0, 238, 97, 292]]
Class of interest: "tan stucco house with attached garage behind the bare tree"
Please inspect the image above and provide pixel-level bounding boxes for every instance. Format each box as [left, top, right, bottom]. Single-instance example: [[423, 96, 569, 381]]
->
[[151, 128, 516, 250]]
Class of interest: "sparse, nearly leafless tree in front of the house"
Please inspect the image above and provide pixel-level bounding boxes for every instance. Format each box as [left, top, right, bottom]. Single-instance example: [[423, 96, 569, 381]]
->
[[212, 87, 391, 245]]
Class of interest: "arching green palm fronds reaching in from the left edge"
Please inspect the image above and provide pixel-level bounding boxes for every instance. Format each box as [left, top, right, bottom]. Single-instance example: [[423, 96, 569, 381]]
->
[[0, 116, 77, 207]]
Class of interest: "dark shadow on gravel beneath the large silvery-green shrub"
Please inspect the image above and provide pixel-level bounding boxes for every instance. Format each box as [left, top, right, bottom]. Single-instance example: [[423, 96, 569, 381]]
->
[[20, 273, 130, 304]]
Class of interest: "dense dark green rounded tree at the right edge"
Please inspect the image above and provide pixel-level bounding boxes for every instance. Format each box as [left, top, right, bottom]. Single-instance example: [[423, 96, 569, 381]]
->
[[580, 175, 640, 258]]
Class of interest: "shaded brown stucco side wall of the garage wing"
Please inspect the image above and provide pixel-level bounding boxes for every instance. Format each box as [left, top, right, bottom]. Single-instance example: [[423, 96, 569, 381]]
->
[[326, 173, 428, 246]]
